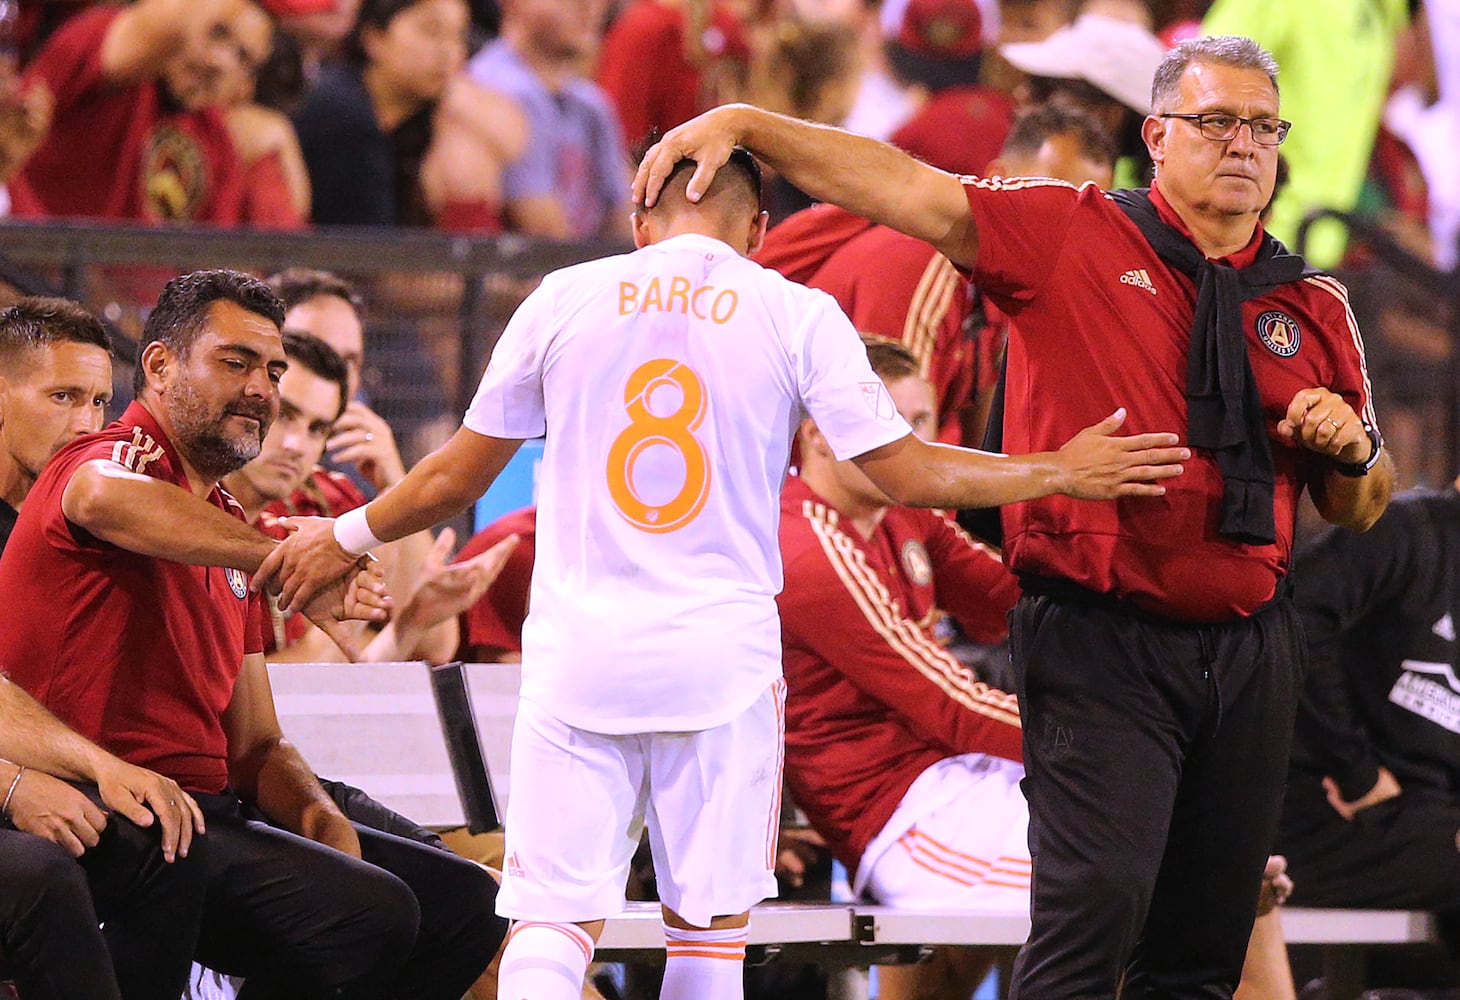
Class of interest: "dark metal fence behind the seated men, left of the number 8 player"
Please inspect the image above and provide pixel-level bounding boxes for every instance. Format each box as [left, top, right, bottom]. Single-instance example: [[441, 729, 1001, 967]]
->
[[0, 222, 625, 461]]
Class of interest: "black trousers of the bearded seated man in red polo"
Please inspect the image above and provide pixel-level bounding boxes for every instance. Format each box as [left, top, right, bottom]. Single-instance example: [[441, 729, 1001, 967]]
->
[[197, 796, 505, 1000]]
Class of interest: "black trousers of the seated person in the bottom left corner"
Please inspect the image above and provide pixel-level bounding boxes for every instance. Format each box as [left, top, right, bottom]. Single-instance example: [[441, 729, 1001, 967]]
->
[[0, 785, 207, 1000]]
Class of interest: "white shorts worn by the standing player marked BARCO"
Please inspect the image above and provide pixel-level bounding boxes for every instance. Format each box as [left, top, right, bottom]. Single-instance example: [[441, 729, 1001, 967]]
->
[[496, 679, 785, 927]]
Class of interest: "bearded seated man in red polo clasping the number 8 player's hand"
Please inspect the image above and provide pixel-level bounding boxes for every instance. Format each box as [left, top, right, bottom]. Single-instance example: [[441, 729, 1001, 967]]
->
[[0, 272, 505, 1000]]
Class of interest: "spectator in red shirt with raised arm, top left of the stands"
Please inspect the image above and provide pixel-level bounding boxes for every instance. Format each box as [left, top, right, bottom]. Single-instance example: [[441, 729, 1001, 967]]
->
[[10, 0, 272, 225]]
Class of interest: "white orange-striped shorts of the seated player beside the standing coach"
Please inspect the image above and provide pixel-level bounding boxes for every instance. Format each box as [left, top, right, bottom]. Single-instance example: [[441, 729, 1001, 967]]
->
[[854, 753, 1029, 914]]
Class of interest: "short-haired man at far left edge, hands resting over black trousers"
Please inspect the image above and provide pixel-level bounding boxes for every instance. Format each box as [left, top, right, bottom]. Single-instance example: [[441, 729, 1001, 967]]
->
[[0, 298, 203, 1000]]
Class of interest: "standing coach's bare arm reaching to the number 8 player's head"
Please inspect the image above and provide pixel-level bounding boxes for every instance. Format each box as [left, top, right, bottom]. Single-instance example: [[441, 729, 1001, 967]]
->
[[634, 104, 978, 267]]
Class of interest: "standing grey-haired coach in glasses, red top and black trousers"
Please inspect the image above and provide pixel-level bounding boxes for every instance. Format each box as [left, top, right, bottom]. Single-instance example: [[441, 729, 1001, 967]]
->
[[635, 31, 1393, 1000]]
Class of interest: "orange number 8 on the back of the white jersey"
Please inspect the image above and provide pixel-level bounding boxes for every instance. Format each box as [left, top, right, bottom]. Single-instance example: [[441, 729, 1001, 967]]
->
[[607, 358, 710, 534]]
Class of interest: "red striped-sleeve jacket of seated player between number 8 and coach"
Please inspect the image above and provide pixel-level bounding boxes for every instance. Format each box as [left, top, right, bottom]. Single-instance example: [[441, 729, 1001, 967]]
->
[[777, 477, 1022, 872]]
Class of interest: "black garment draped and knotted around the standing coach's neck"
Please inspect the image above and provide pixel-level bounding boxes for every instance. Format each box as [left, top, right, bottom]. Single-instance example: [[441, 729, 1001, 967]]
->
[[1111, 188, 1318, 545]]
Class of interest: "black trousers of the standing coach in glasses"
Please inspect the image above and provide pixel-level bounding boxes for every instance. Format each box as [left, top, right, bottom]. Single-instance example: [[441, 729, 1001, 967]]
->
[[1010, 594, 1305, 1000]]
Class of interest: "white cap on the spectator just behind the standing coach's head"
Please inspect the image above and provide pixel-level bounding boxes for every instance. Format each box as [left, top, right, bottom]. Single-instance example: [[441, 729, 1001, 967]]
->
[[999, 13, 1167, 114]]
